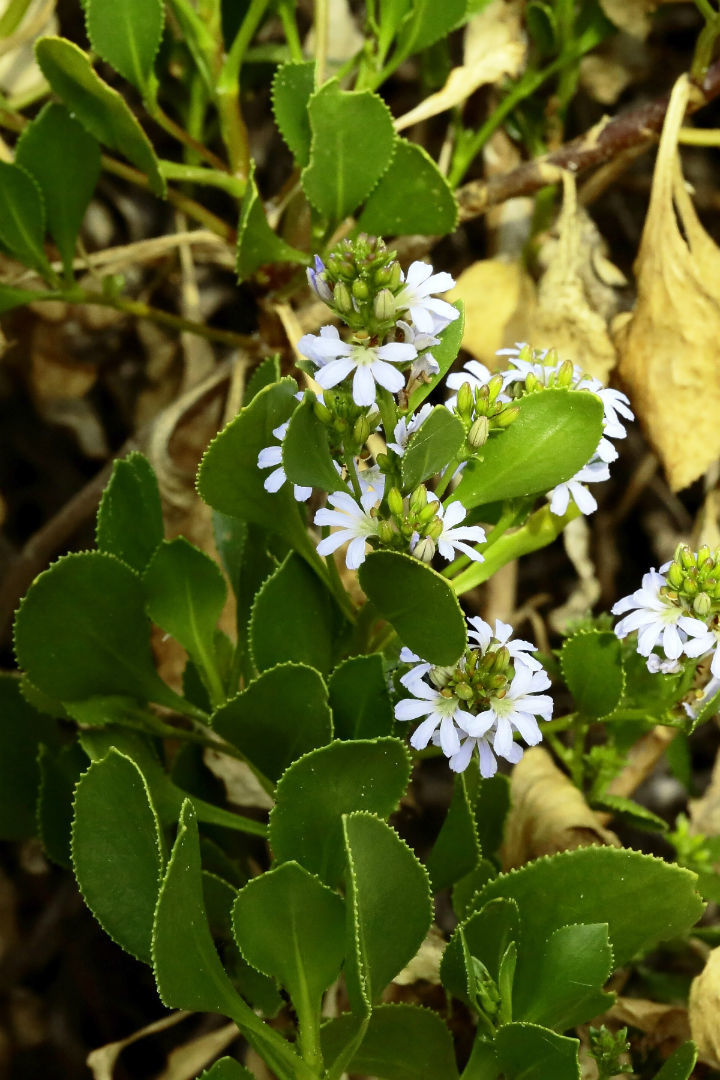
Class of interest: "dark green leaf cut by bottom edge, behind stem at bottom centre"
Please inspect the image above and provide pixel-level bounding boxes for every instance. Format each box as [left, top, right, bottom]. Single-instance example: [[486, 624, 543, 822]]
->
[[321, 1004, 458, 1080]]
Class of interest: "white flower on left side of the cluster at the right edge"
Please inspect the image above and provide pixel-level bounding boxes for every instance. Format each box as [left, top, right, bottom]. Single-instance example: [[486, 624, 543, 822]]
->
[[612, 569, 707, 660]]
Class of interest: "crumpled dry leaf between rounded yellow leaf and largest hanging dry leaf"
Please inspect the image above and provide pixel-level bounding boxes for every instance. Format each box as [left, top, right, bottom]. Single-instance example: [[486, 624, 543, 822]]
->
[[527, 173, 624, 382]]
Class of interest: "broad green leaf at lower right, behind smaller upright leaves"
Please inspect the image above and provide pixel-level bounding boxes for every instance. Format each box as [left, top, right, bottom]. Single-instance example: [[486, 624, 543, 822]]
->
[[477, 848, 703, 1014]]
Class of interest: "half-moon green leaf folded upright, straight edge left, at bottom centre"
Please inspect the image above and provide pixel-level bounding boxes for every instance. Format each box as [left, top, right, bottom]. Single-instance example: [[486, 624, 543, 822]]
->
[[342, 812, 433, 1013]]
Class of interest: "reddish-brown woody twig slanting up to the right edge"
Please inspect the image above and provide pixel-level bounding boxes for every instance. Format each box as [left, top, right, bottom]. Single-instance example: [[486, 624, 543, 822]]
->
[[456, 60, 720, 221]]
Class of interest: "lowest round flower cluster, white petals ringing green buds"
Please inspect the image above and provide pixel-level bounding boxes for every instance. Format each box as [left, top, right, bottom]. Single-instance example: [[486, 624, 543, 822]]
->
[[395, 618, 553, 777]]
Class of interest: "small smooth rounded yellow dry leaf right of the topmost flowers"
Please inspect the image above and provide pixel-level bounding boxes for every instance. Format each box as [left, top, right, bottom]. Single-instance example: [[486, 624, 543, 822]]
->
[[445, 259, 534, 367]]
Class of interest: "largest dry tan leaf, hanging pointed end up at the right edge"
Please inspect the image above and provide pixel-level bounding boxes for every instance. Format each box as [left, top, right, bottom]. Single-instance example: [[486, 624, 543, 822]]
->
[[617, 76, 720, 491]]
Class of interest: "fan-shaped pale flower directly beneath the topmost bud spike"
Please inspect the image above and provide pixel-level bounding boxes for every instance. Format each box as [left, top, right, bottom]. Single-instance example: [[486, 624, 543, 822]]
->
[[298, 327, 418, 405]]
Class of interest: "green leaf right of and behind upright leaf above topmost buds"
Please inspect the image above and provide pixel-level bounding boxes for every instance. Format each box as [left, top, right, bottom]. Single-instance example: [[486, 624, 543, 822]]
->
[[357, 138, 458, 238]]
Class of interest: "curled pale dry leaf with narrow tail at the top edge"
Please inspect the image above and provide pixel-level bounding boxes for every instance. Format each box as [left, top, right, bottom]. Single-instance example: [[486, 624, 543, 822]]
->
[[395, 0, 527, 132]]
